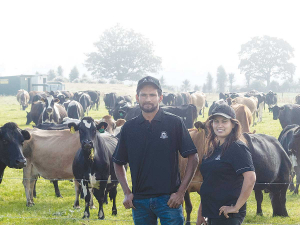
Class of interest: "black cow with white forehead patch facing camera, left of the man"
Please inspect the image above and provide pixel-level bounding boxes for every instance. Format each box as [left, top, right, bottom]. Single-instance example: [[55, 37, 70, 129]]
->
[[69, 117, 118, 219]]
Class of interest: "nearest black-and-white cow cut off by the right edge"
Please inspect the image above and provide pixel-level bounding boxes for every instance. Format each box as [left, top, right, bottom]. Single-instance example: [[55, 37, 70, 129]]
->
[[278, 124, 300, 194]]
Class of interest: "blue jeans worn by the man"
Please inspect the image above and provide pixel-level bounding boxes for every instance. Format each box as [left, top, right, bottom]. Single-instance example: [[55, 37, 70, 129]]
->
[[132, 195, 184, 225]]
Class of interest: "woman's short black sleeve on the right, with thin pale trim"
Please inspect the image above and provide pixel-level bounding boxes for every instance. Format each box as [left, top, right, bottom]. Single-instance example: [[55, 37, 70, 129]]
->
[[231, 143, 255, 175]]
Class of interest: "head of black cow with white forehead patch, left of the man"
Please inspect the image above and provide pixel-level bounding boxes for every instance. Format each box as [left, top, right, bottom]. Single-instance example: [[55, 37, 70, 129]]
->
[[68, 117, 107, 152]]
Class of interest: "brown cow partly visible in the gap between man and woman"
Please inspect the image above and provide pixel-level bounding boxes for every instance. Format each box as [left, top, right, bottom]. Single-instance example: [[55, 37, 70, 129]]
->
[[179, 122, 205, 224]]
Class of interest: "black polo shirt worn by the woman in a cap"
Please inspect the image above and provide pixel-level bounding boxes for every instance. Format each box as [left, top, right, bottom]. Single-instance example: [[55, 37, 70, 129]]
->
[[200, 141, 254, 218]]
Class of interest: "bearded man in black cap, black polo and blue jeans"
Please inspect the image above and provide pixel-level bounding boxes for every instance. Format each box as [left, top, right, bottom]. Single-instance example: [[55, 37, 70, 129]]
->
[[113, 76, 199, 225]]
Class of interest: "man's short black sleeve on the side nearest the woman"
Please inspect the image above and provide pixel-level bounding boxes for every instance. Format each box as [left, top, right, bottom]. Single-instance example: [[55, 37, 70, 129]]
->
[[178, 118, 197, 158]]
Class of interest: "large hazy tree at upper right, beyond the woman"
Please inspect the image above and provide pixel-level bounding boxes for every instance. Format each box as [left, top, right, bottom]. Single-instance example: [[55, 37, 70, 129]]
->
[[239, 36, 296, 87]]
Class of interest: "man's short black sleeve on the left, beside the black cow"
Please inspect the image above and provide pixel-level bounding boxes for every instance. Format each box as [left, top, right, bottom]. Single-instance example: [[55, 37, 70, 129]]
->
[[112, 124, 128, 165]]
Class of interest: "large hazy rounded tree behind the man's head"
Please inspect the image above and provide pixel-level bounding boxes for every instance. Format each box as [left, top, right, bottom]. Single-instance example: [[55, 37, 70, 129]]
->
[[85, 24, 162, 81]]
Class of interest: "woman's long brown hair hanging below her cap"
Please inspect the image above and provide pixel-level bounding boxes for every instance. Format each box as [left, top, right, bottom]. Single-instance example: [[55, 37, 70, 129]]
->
[[204, 119, 246, 157]]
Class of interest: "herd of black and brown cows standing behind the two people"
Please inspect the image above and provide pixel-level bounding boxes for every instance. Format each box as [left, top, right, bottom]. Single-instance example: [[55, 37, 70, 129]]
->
[[0, 90, 300, 221]]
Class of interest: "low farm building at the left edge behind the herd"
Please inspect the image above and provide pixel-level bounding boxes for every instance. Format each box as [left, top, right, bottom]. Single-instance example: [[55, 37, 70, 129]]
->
[[0, 74, 47, 95]]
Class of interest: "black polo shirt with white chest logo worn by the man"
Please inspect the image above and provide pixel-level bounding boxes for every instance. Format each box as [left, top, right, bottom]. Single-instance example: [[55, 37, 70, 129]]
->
[[113, 109, 197, 199]]
